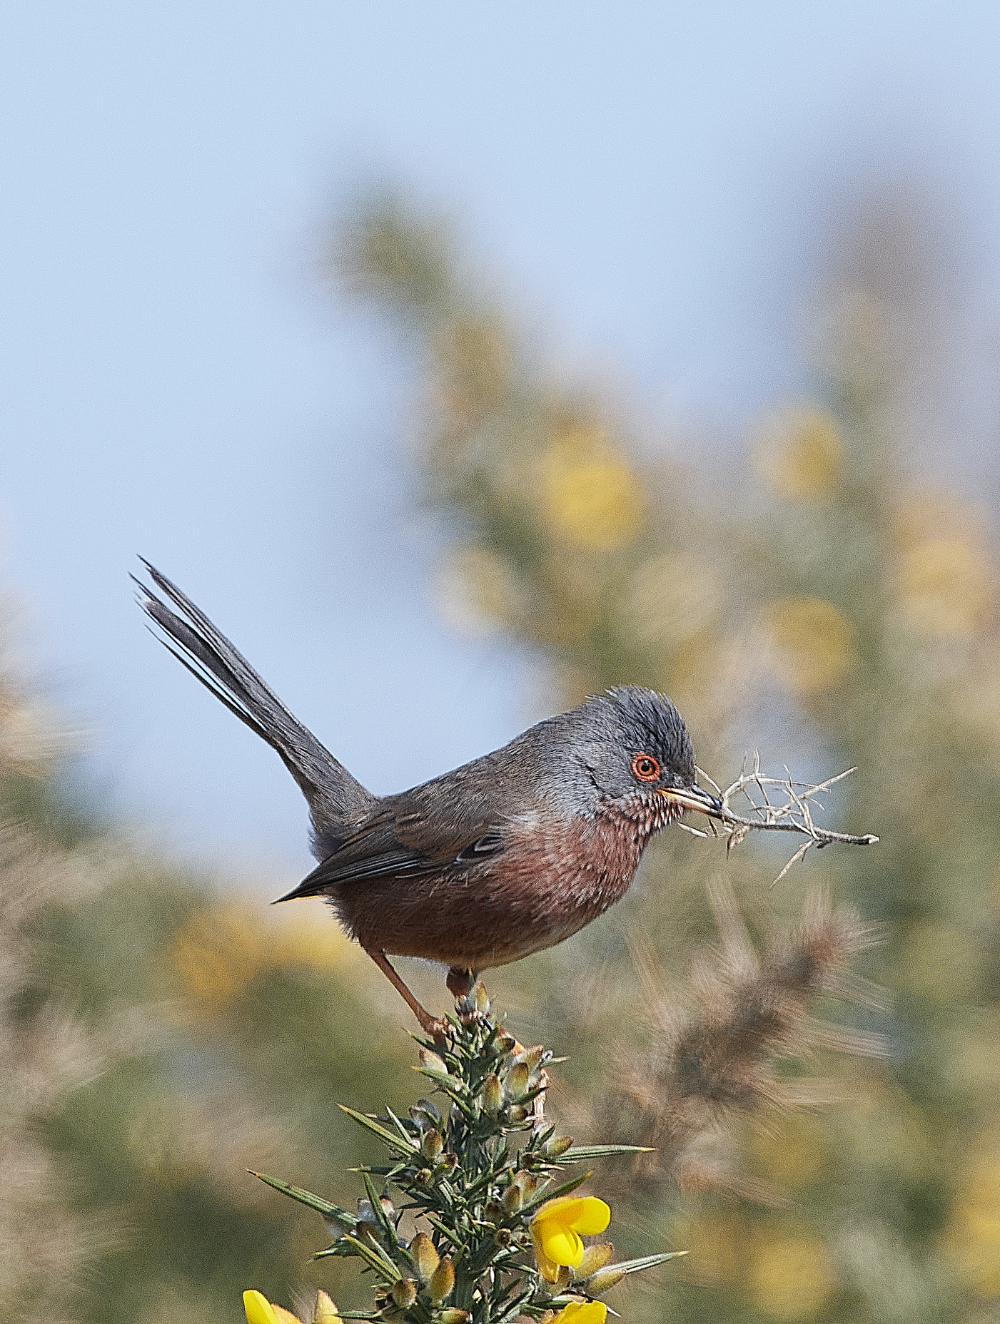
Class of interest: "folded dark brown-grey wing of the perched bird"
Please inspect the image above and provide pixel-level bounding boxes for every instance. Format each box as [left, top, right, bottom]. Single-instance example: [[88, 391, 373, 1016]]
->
[[278, 809, 506, 902]]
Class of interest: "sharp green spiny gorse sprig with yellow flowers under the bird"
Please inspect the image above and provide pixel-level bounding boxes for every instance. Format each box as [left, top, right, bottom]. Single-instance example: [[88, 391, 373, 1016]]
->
[[256, 982, 678, 1324]]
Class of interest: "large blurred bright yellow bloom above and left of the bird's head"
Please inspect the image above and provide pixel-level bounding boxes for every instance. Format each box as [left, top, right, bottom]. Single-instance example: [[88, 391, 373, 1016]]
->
[[539, 429, 645, 551]]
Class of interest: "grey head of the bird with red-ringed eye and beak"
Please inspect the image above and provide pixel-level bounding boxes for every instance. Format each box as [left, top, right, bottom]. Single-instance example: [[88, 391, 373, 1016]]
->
[[566, 685, 722, 824]]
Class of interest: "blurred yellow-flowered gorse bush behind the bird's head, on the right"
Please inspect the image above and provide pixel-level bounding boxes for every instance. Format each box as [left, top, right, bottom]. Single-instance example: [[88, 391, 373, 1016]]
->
[[338, 197, 1000, 1324]]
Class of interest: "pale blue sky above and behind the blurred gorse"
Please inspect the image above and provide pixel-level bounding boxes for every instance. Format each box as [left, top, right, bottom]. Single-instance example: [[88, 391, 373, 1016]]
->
[[0, 0, 1000, 876]]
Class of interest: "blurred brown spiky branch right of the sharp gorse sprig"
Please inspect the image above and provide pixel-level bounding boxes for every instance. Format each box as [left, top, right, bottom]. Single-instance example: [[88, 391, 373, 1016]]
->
[[599, 882, 886, 1202]]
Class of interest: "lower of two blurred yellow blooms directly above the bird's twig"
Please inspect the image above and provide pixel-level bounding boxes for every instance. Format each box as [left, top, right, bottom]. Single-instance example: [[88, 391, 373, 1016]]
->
[[764, 594, 854, 695]]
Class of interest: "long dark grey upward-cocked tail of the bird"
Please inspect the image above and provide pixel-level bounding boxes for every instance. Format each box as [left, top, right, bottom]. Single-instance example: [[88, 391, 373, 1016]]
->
[[132, 559, 375, 859]]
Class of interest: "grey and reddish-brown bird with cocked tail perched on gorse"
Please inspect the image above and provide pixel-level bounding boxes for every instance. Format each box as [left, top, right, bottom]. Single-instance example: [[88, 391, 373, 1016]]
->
[[132, 559, 722, 1041]]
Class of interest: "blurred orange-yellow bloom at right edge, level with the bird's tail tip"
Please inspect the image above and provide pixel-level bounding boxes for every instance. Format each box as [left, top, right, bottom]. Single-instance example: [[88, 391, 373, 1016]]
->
[[899, 534, 995, 637]]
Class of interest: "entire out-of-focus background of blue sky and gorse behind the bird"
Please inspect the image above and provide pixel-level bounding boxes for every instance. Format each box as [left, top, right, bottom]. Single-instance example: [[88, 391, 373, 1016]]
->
[[0, 0, 1000, 1324]]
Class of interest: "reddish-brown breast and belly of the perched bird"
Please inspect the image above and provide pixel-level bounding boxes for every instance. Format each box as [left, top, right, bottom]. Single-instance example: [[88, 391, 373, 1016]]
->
[[334, 824, 645, 970]]
